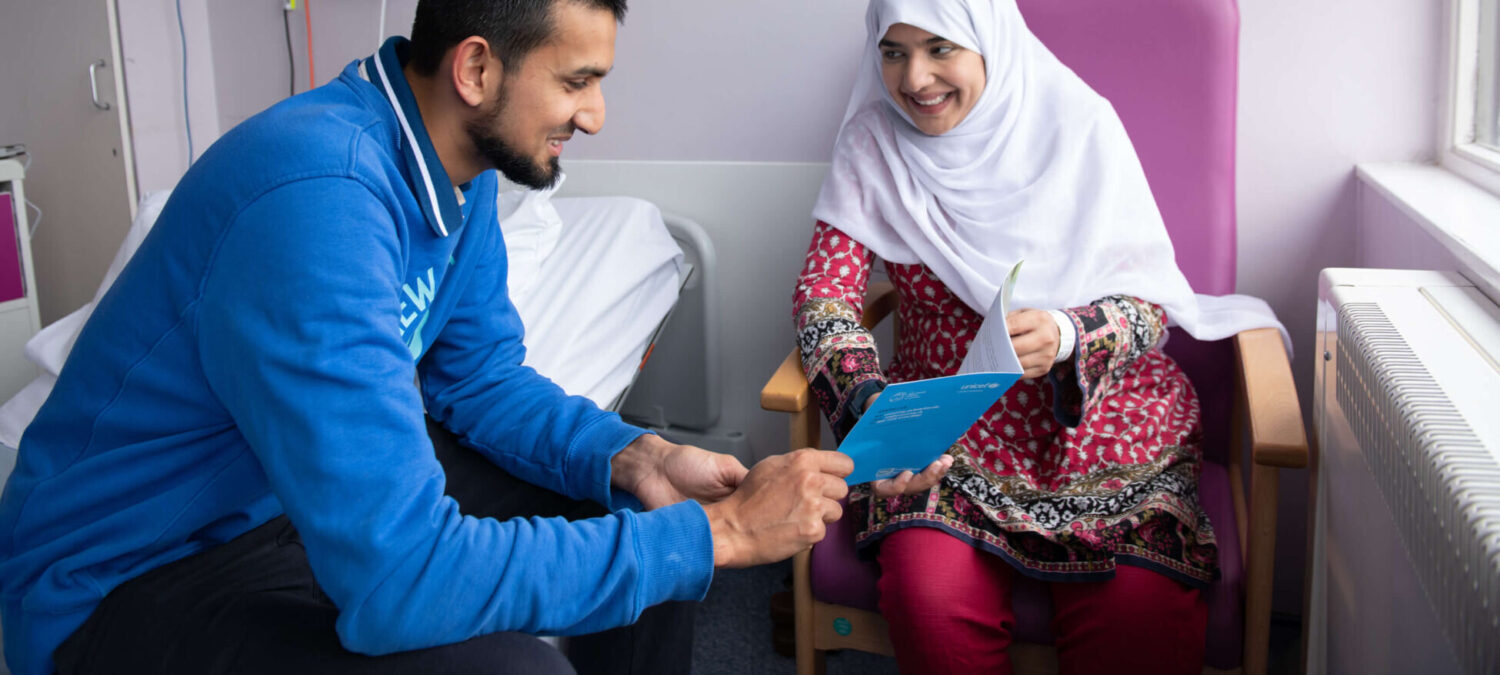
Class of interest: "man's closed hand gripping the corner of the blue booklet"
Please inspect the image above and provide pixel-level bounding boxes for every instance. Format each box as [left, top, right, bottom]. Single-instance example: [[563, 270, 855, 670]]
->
[[704, 449, 854, 567]]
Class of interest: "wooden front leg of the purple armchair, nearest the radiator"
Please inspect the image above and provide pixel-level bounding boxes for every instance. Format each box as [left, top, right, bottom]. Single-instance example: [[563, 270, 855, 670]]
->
[[1245, 465, 1278, 675]]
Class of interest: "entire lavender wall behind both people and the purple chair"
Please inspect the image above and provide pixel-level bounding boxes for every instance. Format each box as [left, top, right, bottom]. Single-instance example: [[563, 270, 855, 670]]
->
[[122, 0, 1443, 612]]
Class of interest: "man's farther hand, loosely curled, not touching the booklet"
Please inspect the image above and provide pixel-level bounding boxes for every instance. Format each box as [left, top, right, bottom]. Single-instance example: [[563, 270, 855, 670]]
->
[[609, 434, 747, 509]]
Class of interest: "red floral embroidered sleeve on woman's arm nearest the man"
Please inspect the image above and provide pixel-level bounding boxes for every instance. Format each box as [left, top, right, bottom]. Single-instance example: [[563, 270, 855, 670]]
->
[[792, 222, 885, 441]]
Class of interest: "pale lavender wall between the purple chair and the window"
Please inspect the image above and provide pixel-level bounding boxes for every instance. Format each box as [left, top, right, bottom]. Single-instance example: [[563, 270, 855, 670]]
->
[[1238, 0, 1443, 614]]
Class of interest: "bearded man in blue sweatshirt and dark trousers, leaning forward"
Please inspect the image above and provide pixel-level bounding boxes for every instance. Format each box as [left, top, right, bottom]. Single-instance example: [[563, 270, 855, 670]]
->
[[0, 0, 876, 675]]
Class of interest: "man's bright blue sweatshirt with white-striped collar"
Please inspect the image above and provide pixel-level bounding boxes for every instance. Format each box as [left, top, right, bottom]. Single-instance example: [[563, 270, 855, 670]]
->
[[0, 38, 713, 675]]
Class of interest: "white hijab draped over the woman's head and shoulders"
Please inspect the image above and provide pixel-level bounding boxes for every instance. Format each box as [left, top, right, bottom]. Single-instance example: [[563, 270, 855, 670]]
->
[[813, 0, 1286, 348]]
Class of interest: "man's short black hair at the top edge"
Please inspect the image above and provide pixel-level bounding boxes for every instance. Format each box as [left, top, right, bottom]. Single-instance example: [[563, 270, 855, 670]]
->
[[411, 0, 626, 75]]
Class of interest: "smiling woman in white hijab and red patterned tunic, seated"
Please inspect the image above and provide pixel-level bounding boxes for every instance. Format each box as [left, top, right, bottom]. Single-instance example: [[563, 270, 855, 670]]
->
[[794, 0, 1278, 675]]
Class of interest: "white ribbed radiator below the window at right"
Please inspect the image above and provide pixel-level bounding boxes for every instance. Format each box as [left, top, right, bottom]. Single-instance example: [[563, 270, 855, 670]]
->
[[1308, 269, 1500, 675]]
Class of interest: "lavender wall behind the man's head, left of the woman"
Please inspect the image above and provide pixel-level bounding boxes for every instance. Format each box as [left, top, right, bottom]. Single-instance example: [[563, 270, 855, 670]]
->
[[198, 0, 864, 162]]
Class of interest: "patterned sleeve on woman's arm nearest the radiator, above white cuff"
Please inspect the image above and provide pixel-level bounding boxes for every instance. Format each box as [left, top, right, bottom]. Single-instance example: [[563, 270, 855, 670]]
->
[[1047, 296, 1167, 426]]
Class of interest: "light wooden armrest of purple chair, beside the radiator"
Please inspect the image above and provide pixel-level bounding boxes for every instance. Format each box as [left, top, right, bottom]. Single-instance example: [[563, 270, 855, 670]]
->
[[1235, 329, 1308, 468]]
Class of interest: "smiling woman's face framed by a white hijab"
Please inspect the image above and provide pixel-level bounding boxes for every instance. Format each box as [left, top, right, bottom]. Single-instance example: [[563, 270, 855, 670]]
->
[[879, 24, 984, 137]]
